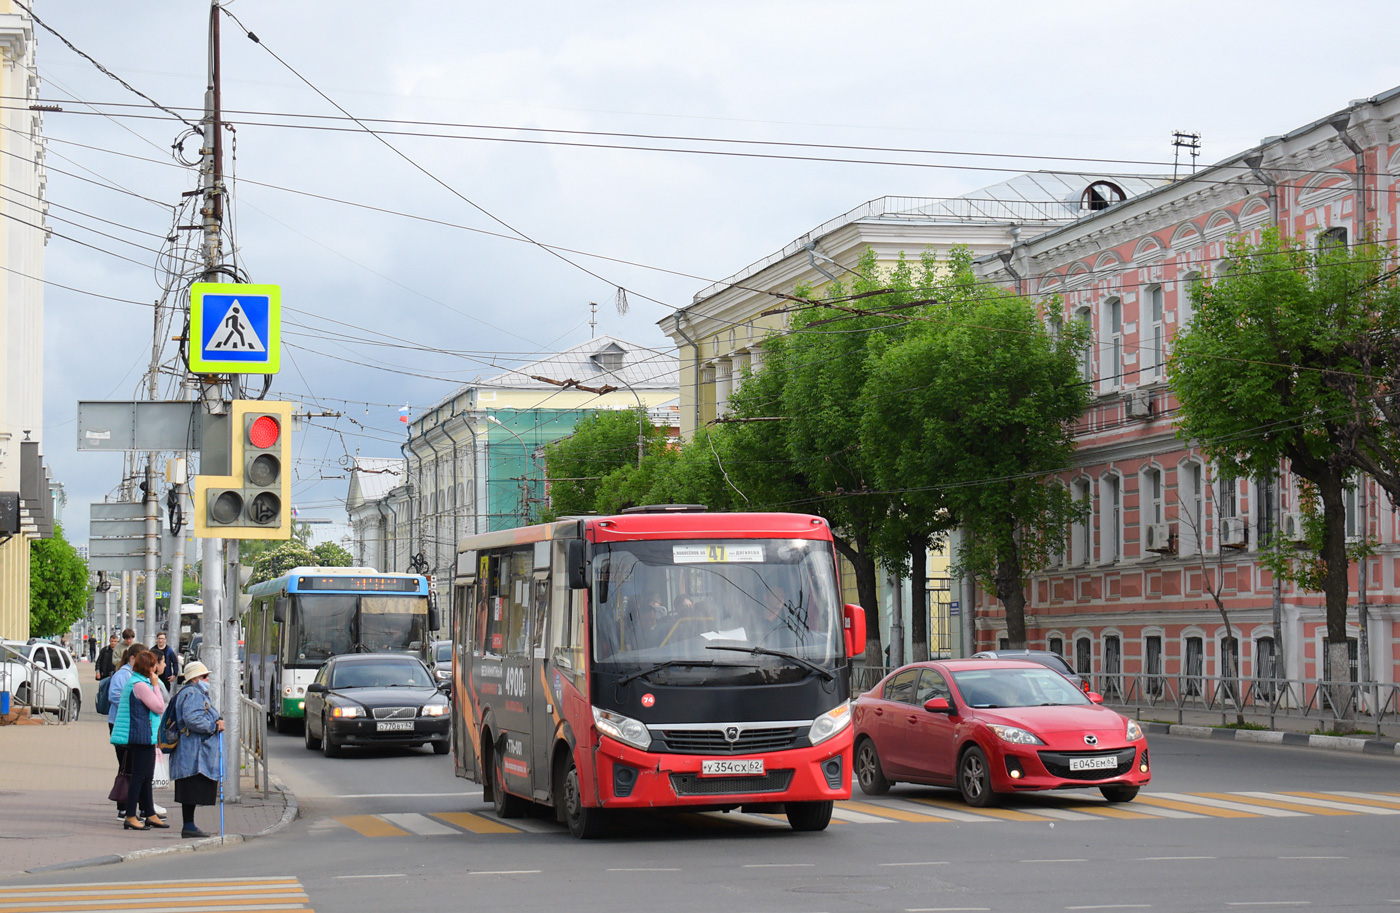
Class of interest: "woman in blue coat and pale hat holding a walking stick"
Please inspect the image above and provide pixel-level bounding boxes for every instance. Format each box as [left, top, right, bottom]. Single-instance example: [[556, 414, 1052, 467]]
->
[[160, 660, 224, 839]]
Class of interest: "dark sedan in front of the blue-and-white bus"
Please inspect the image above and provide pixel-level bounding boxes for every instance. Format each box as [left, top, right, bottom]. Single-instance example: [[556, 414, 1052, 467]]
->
[[304, 653, 452, 758]]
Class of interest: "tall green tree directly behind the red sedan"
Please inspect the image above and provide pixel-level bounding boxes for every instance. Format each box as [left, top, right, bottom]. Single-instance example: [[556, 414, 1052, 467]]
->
[[860, 259, 1088, 648]]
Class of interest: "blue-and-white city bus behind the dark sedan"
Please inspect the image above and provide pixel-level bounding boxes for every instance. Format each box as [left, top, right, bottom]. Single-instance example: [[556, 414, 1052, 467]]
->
[[242, 567, 437, 732]]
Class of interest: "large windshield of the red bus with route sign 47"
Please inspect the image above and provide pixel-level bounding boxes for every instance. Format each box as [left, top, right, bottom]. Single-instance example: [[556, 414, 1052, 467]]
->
[[594, 539, 841, 682]]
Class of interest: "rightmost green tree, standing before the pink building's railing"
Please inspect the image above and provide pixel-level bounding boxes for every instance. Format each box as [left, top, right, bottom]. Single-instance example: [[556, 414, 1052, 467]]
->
[[1168, 230, 1377, 700]]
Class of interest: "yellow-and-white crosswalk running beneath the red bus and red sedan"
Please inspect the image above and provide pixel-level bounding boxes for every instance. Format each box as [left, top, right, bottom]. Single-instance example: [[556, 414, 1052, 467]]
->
[[318, 790, 1400, 837]]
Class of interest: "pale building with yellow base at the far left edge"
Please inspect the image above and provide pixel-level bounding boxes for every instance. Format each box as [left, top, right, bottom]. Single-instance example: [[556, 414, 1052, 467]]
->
[[0, 7, 53, 640]]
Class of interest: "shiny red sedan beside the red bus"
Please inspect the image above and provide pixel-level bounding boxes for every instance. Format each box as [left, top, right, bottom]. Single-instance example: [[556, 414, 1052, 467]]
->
[[854, 660, 1152, 807]]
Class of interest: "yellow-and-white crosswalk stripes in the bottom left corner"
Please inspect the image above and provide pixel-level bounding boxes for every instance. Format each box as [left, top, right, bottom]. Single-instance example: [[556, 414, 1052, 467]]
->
[[0, 878, 311, 913]]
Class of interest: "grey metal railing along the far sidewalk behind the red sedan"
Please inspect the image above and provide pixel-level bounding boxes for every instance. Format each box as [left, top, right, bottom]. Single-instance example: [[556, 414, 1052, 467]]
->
[[851, 667, 1400, 737]]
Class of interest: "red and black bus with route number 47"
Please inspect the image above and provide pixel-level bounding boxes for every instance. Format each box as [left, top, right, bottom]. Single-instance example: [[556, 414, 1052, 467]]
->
[[452, 506, 865, 837]]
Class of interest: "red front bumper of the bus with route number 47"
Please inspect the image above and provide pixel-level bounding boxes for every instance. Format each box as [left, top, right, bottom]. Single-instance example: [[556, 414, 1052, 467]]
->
[[584, 727, 853, 808]]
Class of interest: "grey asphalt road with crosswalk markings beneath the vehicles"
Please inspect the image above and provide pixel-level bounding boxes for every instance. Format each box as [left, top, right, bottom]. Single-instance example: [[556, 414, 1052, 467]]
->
[[8, 735, 1400, 913]]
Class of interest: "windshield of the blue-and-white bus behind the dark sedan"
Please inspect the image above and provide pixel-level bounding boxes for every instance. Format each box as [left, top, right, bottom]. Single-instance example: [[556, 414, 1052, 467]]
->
[[286, 594, 428, 665]]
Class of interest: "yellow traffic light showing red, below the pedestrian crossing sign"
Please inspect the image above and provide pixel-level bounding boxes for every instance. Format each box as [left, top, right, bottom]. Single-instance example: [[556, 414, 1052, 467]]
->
[[195, 399, 291, 539]]
